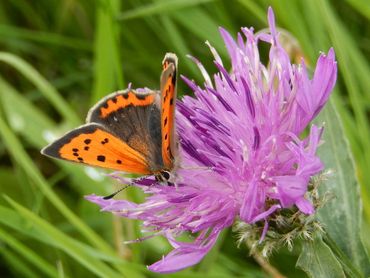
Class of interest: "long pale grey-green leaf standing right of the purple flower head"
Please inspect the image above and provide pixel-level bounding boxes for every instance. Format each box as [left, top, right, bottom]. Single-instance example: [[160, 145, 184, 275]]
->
[[316, 102, 370, 276]]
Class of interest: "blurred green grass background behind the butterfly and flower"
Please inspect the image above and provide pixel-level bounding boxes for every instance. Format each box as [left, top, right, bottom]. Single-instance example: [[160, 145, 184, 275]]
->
[[0, 0, 370, 277]]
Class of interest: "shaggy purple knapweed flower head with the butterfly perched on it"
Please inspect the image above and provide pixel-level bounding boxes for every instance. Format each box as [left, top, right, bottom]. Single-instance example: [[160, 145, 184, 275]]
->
[[87, 8, 337, 273]]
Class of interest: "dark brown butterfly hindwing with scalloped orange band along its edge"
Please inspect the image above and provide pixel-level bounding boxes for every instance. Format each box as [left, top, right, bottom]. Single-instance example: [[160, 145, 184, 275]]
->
[[86, 90, 163, 172]]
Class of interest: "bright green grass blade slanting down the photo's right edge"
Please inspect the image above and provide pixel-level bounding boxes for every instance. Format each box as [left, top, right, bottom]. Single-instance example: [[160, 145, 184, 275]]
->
[[312, 0, 370, 221]]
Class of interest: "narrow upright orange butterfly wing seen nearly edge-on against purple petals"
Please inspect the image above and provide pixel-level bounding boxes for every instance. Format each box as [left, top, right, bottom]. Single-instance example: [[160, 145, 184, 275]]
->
[[161, 53, 177, 170]]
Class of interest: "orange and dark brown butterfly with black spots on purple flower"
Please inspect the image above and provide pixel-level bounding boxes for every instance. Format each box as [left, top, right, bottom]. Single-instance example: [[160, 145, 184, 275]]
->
[[41, 53, 178, 184]]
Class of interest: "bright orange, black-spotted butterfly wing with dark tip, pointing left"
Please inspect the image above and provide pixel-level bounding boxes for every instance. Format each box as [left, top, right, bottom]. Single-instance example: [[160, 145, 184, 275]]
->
[[41, 123, 150, 174]]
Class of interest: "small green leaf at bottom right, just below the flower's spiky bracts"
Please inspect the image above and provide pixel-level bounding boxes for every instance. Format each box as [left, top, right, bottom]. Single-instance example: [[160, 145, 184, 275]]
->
[[296, 237, 346, 278]]
